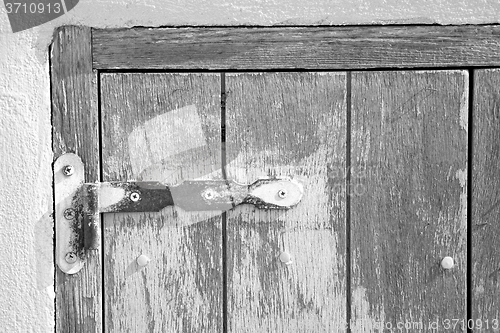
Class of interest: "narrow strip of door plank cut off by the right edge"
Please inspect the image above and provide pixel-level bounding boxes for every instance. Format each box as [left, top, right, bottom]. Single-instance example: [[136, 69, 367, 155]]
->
[[472, 69, 500, 326]]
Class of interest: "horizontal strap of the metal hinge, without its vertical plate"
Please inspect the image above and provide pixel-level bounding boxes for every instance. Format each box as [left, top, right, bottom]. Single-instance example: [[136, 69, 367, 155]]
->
[[83, 178, 302, 214]]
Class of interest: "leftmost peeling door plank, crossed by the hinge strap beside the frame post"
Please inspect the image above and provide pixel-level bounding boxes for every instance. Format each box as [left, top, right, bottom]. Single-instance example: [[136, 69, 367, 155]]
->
[[101, 74, 223, 333]]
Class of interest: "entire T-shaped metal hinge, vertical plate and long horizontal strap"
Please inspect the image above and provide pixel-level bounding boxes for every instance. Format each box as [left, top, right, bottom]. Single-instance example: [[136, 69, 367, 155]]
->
[[54, 154, 303, 274]]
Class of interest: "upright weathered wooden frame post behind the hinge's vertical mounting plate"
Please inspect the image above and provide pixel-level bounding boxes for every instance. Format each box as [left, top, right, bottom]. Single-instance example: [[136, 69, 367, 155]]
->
[[50, 27, 102, 333]]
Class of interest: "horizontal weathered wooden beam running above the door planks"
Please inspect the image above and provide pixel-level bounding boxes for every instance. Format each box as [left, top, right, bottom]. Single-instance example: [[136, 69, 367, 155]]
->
[[92, 26, 500, 70]]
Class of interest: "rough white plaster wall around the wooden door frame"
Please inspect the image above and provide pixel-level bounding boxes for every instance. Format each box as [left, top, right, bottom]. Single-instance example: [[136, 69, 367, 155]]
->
[[0, 0, 500, 332]]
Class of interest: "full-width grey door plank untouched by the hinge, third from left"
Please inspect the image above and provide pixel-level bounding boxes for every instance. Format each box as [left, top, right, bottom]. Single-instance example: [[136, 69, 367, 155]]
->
[[350, 71, 468, 332]]
